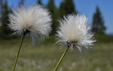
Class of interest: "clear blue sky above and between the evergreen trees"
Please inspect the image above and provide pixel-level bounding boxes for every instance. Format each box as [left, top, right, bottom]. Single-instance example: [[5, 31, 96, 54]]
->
[[8, 0, 113, 34]]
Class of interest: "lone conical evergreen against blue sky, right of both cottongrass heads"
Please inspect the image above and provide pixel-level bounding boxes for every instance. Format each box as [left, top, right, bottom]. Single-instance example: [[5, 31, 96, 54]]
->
[[92, 7, 106, 34]]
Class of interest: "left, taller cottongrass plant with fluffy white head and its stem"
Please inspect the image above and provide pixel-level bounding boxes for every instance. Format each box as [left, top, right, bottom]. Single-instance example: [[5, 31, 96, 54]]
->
[[9, 5, 51, 71]]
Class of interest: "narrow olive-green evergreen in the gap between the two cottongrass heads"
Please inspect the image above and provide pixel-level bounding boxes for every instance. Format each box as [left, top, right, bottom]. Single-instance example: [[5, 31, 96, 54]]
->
[[47, 0, 58, 35]]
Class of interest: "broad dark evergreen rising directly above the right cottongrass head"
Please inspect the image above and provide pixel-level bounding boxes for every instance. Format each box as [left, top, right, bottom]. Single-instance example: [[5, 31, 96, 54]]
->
[[60, 0, 77, 17]]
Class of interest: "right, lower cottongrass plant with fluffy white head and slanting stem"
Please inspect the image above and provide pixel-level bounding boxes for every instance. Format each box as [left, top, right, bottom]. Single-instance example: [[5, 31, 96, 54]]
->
[[54, 14, 95, 71]]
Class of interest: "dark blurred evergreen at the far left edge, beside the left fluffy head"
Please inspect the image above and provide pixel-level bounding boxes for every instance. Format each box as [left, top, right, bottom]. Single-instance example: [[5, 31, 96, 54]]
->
[[0, 0, 11, 38]]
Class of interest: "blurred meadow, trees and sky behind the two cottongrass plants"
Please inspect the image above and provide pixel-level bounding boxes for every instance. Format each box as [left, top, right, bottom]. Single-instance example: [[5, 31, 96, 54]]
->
[[0, 0, 113, 71]]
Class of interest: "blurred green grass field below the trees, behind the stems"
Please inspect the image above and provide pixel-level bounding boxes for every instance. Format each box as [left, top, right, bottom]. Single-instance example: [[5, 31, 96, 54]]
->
[[0, 37, 113, 71]]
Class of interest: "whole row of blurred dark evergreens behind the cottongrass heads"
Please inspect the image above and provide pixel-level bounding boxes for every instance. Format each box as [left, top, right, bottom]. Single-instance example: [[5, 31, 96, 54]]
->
[[0, 0, 106, 39]]
